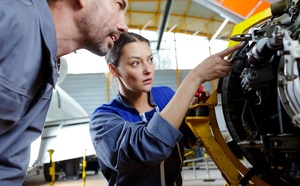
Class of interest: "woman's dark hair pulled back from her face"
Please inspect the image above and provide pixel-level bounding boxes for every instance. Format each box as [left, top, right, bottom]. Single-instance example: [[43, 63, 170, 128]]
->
[[105, 32, 150, 67]]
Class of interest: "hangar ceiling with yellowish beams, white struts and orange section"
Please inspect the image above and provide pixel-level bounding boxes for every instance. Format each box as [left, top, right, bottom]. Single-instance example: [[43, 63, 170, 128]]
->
[[126, 0, 277, 50]]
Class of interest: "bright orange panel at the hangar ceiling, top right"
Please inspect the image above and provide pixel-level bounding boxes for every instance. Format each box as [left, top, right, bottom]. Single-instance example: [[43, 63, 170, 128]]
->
[[222, 0, 260, 18]]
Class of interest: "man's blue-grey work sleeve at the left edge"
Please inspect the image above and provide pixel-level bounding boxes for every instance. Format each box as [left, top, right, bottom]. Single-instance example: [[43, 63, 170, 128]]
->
[[0, 1, 46, 122]]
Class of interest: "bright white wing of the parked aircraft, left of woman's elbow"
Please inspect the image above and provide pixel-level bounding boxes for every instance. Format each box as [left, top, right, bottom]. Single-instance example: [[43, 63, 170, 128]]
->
[[33, 117, 96, 167]]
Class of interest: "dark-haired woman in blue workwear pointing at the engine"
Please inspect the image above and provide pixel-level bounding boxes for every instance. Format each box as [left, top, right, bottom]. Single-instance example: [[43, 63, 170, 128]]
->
[[90, 33, 239, 186]]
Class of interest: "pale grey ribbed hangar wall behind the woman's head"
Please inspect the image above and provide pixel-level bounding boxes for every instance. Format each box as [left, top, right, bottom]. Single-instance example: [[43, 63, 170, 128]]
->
[[60, 70, 216, 115]]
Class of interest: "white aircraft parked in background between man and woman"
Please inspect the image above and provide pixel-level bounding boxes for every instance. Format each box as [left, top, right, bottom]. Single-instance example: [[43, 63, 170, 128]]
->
[[28, 58, 99, 181]]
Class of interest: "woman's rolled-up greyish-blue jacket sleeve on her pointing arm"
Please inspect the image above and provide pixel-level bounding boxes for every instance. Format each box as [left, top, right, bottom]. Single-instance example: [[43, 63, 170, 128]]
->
[[90, 112, 182, 171]]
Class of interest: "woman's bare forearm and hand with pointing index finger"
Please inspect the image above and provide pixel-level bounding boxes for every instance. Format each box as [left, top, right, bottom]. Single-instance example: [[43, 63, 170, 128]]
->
[[160, 45, 242, 129]]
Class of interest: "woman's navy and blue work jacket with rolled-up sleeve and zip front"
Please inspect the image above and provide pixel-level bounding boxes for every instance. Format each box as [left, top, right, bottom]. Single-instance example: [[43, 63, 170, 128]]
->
[[90, 87, 183, 186]]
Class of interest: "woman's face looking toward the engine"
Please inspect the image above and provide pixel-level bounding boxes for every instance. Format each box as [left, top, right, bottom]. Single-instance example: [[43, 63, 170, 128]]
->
[[117, 42, 154, 93]]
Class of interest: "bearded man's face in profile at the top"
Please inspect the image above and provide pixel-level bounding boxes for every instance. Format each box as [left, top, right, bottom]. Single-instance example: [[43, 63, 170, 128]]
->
[[79, 0, 128, 56]]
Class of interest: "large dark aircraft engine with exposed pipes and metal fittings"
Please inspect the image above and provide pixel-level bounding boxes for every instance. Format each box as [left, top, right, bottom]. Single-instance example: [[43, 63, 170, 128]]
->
[[218, 0, 300, 186]]
